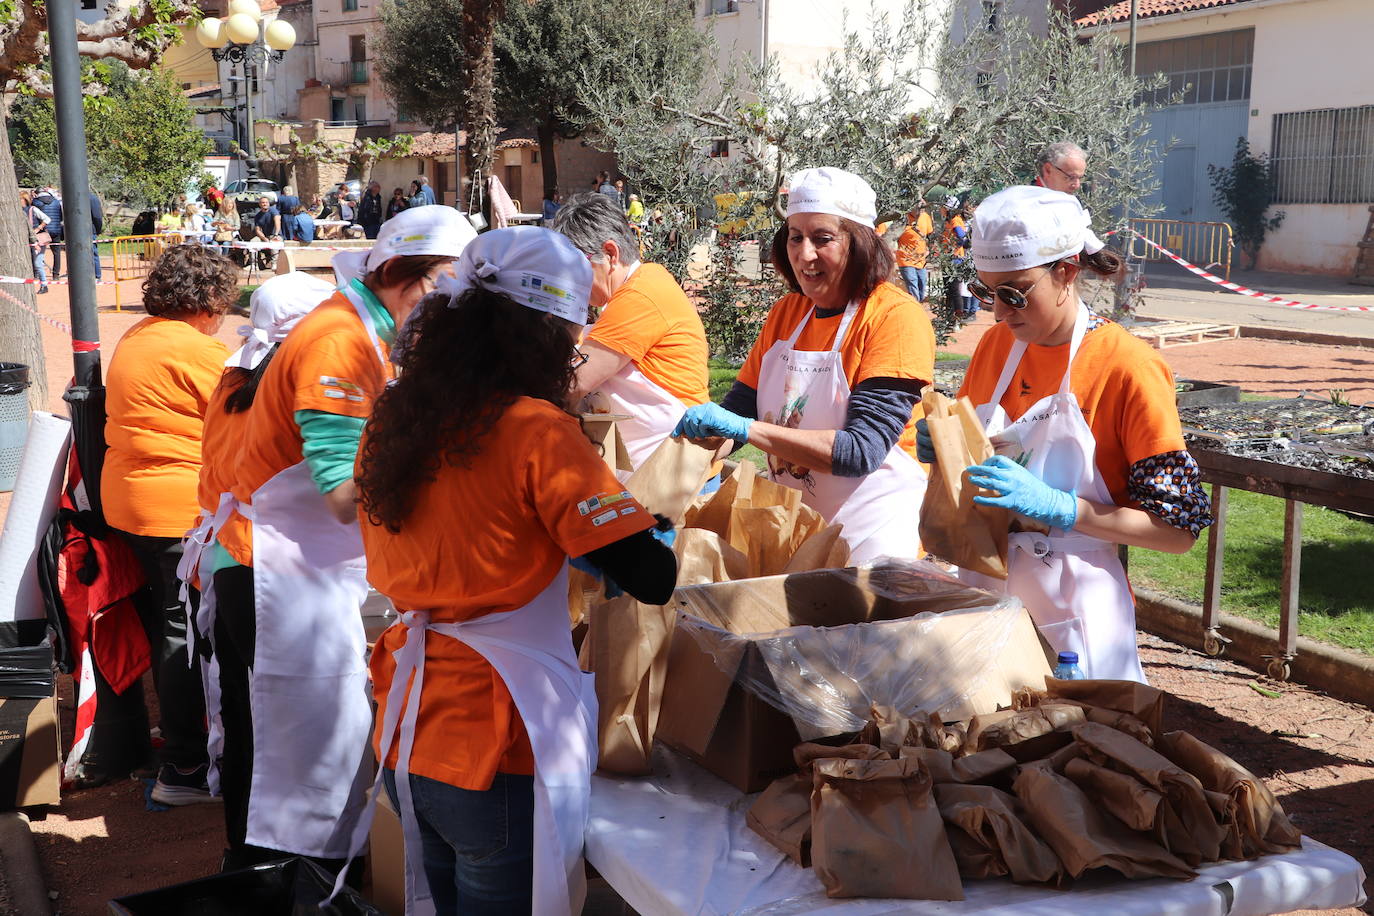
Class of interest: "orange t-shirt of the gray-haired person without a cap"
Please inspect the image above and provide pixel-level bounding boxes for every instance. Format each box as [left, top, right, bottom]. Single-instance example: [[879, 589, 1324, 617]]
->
[[587, 264, 710, 407]]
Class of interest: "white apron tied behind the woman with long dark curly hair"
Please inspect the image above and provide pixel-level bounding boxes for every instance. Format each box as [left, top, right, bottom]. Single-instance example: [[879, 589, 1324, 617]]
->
[[334, 566, 596, 916]]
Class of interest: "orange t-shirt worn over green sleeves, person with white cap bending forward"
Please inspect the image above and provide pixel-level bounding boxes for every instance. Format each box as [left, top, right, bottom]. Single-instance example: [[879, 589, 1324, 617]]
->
[[216, 293, 392, 566]]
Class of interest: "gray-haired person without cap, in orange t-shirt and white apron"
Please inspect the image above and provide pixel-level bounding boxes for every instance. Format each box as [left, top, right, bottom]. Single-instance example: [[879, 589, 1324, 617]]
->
[[552, 194, 710, 467]]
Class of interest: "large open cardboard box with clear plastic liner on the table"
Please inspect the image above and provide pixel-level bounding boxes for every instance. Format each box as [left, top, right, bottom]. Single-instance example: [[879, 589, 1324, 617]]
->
[[657, 564, 1050, 792]]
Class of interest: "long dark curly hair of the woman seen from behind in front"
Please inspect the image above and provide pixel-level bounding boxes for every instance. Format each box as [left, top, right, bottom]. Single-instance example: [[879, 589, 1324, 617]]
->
[[357, 288, 577, 531]]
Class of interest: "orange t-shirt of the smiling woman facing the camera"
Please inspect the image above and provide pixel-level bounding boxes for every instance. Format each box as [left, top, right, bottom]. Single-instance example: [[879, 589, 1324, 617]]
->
[[739, 283, 936, 457]]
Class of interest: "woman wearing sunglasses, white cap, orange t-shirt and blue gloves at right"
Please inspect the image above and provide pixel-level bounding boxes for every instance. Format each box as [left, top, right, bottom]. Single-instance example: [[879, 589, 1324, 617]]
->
[[919, 187, 1212, 683]]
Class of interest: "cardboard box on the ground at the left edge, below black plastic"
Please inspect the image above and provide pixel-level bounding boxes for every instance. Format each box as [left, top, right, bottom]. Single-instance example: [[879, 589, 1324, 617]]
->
[[0, 696, 62, 810]]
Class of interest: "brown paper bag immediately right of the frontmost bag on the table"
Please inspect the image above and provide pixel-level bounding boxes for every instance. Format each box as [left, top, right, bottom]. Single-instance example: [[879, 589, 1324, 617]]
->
[[934, 784, 1063, 884]]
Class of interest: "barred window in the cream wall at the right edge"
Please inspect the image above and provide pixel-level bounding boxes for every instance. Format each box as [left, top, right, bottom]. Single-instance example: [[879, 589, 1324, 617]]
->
[[1270, 104, 1374, 203]]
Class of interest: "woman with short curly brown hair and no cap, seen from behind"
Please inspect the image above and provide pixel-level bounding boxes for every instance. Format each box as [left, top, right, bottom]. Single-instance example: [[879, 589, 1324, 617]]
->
[[92, 246, 239, 805]]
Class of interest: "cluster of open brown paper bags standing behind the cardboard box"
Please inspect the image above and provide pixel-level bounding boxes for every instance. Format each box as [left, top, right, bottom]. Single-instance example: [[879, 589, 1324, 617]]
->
[[677, 461, 849, 585]]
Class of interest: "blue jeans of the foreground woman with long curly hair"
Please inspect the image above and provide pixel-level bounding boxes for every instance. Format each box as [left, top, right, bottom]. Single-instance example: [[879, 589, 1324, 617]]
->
[[382, 769, 534, 916]]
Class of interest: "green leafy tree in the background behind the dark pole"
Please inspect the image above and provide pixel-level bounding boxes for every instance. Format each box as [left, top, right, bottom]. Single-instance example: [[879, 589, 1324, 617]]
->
[[10, 63, 212, 207]]
